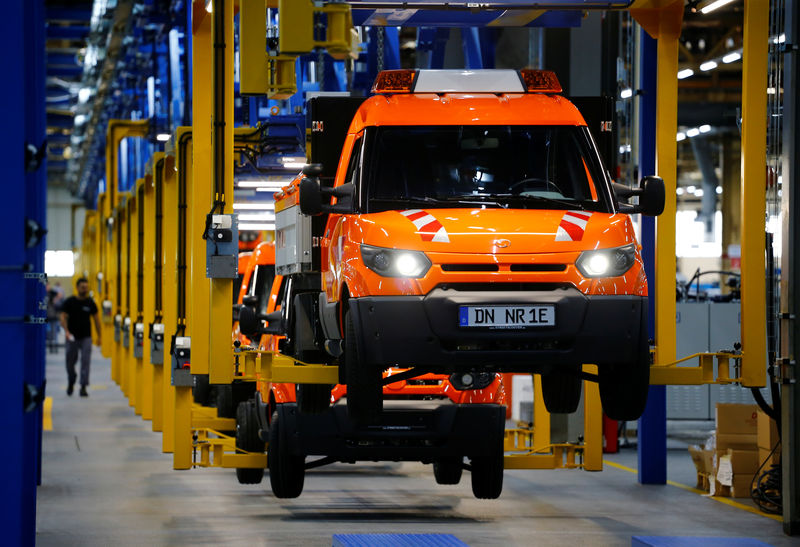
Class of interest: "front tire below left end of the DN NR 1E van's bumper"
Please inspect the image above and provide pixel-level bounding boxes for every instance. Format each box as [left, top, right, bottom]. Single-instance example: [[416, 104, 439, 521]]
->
[[344, 311, 383, 426]]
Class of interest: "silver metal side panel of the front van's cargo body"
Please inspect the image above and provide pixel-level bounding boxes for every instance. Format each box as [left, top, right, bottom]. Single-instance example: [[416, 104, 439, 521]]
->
[[275, 198, 314, 275]]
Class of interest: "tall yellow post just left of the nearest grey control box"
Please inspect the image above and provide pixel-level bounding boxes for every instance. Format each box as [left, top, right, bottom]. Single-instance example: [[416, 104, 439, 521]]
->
[[185, 2, 211, 382]]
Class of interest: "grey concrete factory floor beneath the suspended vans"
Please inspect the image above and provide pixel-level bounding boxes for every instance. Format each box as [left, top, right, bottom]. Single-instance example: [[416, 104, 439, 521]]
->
[[37, 350, 798, 546]]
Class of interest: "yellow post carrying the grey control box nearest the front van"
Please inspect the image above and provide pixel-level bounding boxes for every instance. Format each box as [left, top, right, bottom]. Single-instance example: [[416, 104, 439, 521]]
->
[[206, 1, 234, 384]]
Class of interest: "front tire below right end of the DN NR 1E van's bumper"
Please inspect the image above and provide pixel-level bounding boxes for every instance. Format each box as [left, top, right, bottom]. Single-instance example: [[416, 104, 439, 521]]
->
[[598, 329, 650, 422]]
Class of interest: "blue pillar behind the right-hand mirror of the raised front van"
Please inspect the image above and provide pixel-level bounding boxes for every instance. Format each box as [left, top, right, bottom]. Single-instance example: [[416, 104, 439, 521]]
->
[[638, 30, 671, 484]]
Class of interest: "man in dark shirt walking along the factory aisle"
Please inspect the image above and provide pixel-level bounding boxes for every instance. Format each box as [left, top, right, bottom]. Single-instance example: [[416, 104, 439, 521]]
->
[[61, 277, 101, 397]]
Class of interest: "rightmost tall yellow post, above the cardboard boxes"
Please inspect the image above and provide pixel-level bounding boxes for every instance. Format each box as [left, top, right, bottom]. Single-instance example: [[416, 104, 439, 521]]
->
[[741, 0, 774, 387]]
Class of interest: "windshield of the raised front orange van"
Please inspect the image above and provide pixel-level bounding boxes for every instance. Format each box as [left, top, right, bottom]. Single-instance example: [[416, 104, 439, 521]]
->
[[361, 125, 613, 212]]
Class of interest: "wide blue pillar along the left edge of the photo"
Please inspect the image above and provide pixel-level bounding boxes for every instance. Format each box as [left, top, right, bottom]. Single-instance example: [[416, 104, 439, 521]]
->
[[0, 0, 46, 545]]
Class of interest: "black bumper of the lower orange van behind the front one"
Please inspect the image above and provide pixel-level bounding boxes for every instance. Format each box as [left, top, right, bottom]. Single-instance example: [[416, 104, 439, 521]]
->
[[277, 403, 506, 463]]
